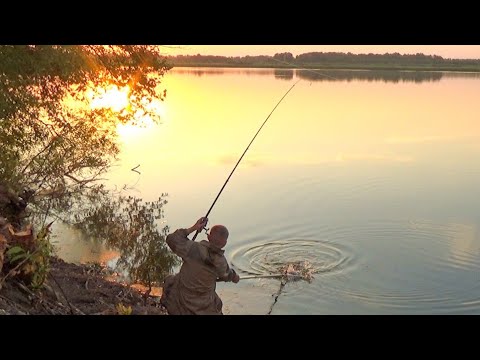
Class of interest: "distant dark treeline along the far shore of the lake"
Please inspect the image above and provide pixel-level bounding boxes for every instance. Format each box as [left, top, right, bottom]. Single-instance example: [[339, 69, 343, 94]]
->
[[167, 52, 480, 71]]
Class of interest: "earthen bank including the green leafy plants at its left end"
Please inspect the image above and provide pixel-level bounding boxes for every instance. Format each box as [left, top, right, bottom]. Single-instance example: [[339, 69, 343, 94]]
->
[[0, 215, 166, 315]]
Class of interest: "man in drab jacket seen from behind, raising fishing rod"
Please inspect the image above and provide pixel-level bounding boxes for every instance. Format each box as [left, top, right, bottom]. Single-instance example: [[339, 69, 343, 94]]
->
[[161, 217, 240, 315]]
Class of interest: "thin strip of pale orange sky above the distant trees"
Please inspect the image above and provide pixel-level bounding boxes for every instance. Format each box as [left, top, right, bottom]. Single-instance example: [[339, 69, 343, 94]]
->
[[163, 45, 480, 59]]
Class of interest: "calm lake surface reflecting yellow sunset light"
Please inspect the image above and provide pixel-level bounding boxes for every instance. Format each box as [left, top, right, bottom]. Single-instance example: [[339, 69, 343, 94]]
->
[[53, 68, 480, 314]]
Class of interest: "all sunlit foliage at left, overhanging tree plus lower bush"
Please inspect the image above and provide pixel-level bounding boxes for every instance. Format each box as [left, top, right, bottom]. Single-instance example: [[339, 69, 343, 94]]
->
[[0, 45, 175, 287]]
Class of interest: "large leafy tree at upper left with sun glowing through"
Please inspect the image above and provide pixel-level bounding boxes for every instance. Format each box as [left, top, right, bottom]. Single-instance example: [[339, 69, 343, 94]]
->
[[0, 45, 180, 286]]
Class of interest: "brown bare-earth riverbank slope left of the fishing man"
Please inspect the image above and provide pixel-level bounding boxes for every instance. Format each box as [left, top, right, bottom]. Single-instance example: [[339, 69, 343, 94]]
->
[[0, 257, 166, 315]]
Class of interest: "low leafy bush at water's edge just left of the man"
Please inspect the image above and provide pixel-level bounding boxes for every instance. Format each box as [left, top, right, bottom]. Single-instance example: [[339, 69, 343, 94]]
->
[[75, 194, 179, 287]]
